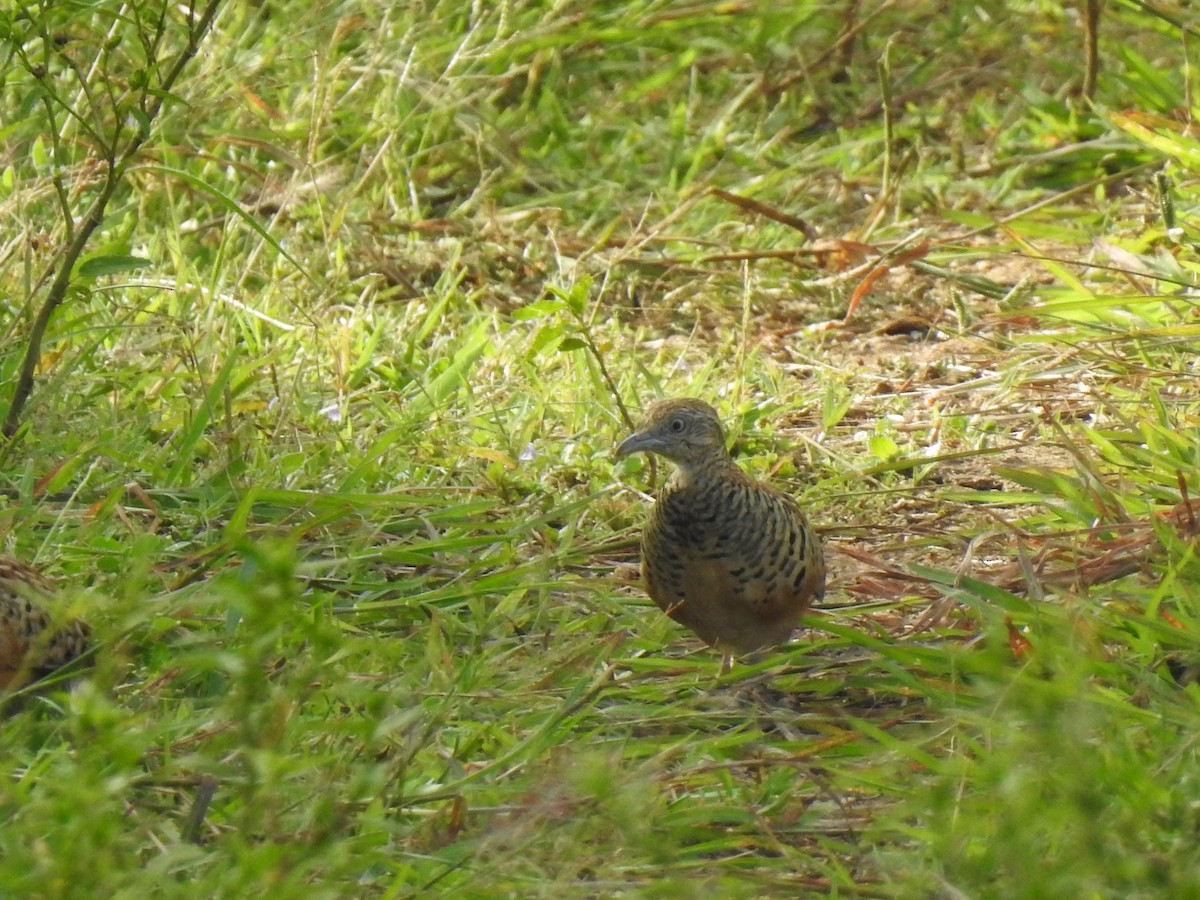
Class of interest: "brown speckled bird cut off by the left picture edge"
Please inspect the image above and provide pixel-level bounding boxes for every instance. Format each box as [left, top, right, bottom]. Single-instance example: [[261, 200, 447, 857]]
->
[[0, 557, 91, 692]]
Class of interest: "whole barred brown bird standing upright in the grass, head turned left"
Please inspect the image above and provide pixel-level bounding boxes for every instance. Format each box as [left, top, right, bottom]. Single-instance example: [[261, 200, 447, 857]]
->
[[616, 398, 826, 671]]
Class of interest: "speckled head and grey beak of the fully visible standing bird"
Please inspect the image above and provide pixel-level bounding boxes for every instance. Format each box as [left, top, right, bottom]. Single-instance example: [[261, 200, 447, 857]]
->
[[616, 397, 731, 481]]
